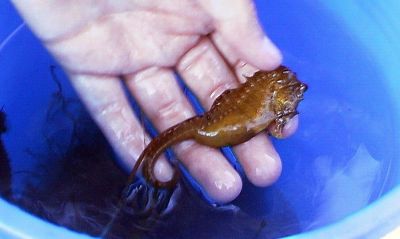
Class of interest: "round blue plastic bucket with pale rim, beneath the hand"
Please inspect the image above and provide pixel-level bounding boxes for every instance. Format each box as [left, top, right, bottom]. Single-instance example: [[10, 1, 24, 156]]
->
[[0, 0, 400, 239]]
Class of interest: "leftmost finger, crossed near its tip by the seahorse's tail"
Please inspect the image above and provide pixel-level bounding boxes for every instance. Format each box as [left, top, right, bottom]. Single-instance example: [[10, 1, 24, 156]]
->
[[70, 74, 173, 181]]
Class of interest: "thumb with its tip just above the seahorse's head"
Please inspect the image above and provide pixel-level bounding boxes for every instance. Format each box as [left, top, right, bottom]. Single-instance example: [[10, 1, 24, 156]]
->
[[199, 0, 282, 70]]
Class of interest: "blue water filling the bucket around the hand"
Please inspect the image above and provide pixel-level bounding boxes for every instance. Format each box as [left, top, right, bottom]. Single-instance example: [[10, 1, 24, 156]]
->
[[0, 0, 399, 238]]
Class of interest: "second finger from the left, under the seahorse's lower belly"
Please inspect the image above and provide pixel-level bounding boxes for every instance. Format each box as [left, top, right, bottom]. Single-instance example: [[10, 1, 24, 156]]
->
[[126, 68, 242, 203]]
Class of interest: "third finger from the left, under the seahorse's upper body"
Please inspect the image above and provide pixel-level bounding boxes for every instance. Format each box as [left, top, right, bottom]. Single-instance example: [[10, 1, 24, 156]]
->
[[178, 40, 281, 186]]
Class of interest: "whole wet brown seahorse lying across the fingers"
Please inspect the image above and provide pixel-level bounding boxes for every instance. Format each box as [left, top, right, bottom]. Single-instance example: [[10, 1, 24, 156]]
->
[[127, 66, 307, 188]]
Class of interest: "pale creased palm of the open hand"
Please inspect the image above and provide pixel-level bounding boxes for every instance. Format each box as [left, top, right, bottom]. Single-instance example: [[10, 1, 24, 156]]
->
[[24, 1, 211, 75]]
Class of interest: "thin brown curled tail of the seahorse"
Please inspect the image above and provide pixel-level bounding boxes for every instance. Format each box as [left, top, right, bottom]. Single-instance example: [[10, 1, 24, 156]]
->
[[127, 117, 200, 188]]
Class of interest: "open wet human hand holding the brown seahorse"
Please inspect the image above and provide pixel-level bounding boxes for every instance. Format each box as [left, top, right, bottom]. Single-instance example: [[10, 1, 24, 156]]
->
[[12, 0, 297, 203]]
